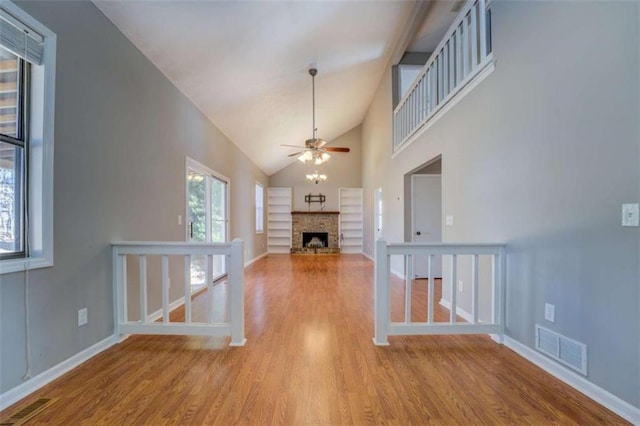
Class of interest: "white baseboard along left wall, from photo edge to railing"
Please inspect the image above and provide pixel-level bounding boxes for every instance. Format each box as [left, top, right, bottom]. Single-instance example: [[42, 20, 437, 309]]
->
[[0, 334, 119, 410]]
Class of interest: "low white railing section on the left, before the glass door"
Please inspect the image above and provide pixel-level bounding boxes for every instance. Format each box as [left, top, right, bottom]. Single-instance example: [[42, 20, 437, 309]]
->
[[112, 239, 246, 346]]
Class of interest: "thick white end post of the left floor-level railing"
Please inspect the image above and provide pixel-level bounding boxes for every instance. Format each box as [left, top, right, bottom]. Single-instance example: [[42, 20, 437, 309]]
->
[[229, 238, 247, 346]]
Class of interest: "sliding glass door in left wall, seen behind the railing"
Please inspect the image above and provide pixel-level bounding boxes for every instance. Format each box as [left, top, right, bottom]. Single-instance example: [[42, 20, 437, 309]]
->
[[187, 162, 228, 287]]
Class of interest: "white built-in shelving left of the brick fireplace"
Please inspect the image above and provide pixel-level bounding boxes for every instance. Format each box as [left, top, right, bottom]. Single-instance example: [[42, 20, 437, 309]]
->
[[267, 187, 291, 253]]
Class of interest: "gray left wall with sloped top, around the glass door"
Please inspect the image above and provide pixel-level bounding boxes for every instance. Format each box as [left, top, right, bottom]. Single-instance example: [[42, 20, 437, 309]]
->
[[0, 1, 268, 392]]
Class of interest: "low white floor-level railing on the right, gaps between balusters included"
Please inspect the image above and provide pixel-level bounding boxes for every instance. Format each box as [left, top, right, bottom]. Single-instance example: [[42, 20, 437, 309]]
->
[[373, 240, 506, 346]]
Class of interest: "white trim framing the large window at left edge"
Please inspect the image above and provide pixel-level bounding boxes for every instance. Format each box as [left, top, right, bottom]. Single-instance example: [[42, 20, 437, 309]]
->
[[0, 0, 57, 274]]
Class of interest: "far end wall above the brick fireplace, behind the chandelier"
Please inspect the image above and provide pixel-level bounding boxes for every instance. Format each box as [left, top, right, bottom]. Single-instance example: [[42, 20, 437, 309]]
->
[[269, 126, 362, 211]]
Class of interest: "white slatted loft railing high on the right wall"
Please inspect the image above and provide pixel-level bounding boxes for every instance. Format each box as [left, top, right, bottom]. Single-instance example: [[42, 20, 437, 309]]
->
[[393, 0, 493, 152]]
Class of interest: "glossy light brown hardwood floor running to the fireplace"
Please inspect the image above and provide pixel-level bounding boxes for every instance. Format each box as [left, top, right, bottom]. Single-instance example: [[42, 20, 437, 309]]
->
[[0, 255, 626, 425]]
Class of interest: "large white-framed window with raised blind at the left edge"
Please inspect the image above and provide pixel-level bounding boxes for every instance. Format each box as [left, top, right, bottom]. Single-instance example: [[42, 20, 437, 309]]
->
[[0, 1, 56, 273]]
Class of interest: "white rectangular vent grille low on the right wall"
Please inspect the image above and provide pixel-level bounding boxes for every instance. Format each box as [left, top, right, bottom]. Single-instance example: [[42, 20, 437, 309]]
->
[[536, 324, 587, 376]]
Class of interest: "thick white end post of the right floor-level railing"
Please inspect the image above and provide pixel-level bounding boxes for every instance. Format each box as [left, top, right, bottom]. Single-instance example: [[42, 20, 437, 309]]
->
[[373, 239, 391, 346]]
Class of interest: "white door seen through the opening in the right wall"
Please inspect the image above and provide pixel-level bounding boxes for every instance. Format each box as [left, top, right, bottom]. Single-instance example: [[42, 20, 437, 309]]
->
[[411, 174, 442, 278]]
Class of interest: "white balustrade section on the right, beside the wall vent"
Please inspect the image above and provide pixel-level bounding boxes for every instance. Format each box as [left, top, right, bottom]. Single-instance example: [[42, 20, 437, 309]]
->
[[373, 240, 506, 346]]
